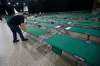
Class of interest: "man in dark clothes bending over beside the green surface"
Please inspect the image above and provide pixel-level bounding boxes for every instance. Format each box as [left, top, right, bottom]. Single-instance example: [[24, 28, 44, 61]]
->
[[7, 15, 28, 43]]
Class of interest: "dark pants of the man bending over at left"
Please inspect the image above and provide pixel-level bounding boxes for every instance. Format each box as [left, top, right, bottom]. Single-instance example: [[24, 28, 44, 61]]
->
[[9, 25, 24, 40]]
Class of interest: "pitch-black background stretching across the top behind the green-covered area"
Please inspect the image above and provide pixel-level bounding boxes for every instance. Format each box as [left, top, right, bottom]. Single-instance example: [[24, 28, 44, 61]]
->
[[0, 0, 94, 14]]
